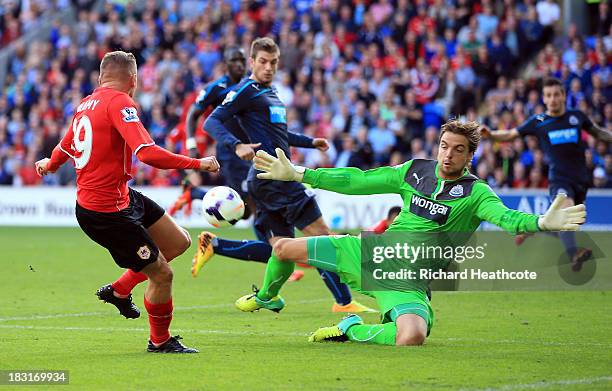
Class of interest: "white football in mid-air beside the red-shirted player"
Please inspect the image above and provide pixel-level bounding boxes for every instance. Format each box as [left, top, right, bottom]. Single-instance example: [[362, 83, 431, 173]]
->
[[202, 186, 244, 228]]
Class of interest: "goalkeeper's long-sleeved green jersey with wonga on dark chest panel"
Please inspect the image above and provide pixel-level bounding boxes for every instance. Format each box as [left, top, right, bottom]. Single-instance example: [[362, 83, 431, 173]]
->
[[303, 159, 539, 233]]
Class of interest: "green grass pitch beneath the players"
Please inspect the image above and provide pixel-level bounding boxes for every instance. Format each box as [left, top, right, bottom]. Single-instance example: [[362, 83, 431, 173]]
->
[[0, 228, 612, 390]]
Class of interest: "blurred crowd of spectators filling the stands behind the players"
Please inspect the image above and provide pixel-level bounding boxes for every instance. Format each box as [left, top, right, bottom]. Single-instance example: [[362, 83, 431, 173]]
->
[[0, 0, 612, 188]]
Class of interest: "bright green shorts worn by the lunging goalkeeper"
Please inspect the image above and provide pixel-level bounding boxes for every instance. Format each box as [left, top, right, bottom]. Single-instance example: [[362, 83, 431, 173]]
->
[[307, 235, 434, 334]]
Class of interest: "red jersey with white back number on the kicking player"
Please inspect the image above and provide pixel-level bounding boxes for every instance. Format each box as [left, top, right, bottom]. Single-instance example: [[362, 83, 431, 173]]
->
[[60, 87, 155, 212]]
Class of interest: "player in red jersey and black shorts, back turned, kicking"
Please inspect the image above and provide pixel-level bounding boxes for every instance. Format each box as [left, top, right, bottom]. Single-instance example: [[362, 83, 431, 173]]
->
[[36, 51, 219, 353]]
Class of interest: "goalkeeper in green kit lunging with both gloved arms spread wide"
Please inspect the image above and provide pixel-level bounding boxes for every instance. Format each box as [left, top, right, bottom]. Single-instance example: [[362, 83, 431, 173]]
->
[[236, 120, 586, 345]]
